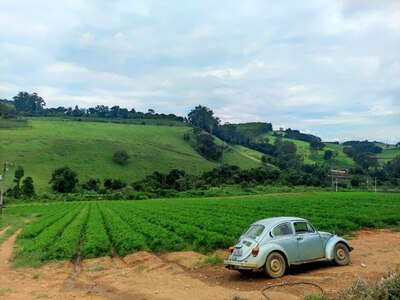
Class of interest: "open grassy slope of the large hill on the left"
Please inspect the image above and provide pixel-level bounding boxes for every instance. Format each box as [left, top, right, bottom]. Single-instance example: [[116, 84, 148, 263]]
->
[[0, 118, 261, 191]]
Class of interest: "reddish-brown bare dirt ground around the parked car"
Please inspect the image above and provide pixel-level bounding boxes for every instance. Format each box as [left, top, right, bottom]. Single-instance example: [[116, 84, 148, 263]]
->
[[0, 230, 400, 300]]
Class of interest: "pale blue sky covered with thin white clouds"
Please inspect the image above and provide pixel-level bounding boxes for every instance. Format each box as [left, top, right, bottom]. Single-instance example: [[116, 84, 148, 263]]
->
[[0, 0, 400, 143]]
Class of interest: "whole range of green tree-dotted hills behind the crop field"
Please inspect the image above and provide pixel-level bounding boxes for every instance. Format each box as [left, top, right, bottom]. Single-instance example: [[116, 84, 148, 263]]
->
[[0, 92, 399, 198]]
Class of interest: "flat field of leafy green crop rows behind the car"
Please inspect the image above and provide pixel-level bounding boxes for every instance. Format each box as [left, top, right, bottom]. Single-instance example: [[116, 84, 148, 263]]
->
[[5, 193, 400, 261]]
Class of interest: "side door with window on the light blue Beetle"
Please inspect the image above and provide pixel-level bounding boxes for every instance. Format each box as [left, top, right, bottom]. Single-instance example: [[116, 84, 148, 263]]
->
[[293, 222, 325, 261]]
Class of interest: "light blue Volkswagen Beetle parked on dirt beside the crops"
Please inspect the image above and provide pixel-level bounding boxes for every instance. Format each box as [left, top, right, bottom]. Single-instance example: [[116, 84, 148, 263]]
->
[[224, 217, 353, 278]]
